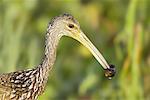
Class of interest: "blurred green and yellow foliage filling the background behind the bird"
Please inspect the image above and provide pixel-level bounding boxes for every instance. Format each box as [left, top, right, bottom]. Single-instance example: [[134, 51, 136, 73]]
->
[[0, 0, 150, 100]]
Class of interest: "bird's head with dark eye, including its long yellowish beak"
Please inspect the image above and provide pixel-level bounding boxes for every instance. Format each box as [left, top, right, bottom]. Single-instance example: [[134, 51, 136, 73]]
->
[[48, 14, 114, 76]]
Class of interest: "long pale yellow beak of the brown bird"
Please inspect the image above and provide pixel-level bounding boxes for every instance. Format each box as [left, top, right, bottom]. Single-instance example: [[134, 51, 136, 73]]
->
[[73, 31, 110, 69]]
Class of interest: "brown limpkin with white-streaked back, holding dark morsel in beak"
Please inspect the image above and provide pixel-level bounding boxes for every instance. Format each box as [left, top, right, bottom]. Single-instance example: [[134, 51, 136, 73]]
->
[[0, 14, 115, 100]]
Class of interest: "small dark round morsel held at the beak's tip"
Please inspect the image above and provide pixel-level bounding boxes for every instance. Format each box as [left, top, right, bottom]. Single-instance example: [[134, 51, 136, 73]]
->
[[105, 65, 116, 79]]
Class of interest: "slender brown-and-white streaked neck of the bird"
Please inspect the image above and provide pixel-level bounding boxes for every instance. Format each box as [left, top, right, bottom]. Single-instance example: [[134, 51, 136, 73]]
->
[[39, 27, 61, 81]]
